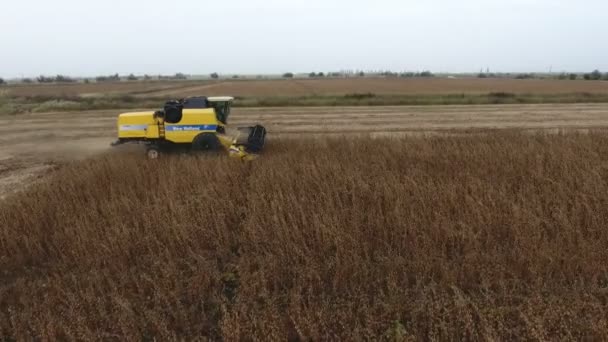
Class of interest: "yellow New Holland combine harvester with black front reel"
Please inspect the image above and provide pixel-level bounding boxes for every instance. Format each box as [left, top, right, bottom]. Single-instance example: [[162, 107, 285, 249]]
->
[[112, 96, 266, 160]]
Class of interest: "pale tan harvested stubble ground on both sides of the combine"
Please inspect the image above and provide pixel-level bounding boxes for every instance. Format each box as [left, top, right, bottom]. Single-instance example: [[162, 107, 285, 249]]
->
[[0, 104, 608, 198]]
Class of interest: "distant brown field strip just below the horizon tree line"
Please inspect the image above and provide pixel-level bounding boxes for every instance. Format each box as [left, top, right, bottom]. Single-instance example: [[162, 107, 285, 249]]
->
[[4, 78, 608, 97]]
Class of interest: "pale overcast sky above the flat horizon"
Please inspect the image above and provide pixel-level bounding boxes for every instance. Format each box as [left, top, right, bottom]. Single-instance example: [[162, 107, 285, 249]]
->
[[0, 0, 608, 77]]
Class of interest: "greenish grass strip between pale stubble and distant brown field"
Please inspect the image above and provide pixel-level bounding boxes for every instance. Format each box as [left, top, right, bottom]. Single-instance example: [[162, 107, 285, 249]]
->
[[0, 92, 608, 115]]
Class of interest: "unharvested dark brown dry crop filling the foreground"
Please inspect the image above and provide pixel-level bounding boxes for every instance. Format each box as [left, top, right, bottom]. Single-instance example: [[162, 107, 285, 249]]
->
[[0, 134, 608, 340]]
